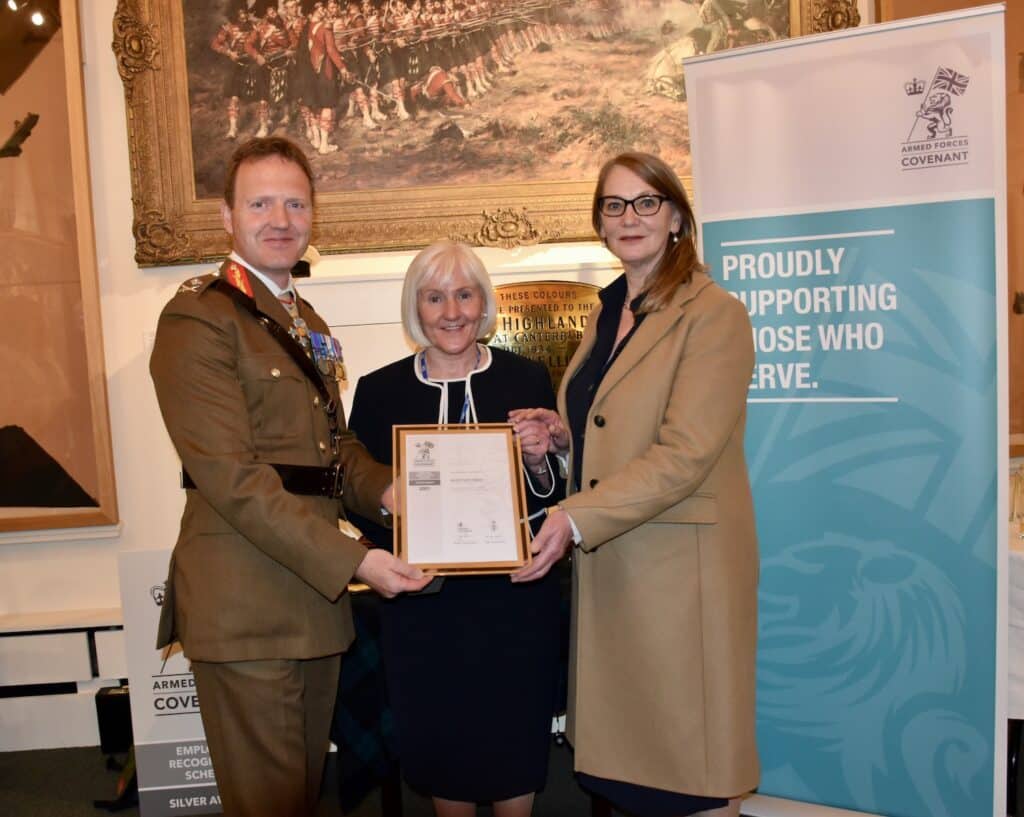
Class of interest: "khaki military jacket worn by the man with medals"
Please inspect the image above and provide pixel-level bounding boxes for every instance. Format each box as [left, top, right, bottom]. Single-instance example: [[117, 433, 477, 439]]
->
[[150, 268, 391, 661]]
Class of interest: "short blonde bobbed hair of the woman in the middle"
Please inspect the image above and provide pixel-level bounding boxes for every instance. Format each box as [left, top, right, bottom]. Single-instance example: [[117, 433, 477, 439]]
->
[[401, 241, 498, 348]]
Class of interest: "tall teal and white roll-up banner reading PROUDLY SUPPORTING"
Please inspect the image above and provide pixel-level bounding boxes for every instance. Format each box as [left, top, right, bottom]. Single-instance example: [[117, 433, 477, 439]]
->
[[685, 6, 1009, 817]]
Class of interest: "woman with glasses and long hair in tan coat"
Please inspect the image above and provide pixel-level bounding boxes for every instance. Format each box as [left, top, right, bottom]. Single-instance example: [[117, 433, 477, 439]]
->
[[510, 153, 759, 817]]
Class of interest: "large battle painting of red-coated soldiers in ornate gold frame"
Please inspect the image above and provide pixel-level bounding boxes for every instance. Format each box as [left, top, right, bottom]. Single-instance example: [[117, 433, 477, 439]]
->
[[114, 0, 856, 263]]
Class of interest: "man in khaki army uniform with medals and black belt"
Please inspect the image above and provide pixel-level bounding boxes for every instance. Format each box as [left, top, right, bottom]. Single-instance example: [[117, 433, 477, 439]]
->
[[150, 137, 428, 817]]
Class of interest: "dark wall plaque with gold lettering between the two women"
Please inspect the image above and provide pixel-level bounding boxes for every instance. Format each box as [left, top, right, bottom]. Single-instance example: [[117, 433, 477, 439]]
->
[[489, 281, 601, 391]]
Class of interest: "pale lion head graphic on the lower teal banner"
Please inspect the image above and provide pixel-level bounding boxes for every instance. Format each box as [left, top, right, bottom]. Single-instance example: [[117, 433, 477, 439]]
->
[[758, 533, 987, 817]]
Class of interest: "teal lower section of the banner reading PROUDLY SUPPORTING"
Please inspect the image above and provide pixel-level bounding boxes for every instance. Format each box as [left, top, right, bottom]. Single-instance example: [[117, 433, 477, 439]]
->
[[702, 199, 1004, 817]]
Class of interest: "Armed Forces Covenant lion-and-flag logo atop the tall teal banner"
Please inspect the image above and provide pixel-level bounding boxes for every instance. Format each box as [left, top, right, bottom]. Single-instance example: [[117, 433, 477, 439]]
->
[[899, 67, 971, 170]]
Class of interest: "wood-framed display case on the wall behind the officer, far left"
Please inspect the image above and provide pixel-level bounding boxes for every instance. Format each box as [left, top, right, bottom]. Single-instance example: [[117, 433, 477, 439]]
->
[[0, 0, 118, 530]]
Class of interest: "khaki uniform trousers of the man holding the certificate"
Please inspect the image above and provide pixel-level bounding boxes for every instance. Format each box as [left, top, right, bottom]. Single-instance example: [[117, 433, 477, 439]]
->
[[193, 655, 341, 817]]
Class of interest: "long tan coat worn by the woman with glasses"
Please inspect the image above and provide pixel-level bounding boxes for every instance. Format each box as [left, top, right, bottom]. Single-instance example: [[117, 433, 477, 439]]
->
[[558, 273, 759, 797]]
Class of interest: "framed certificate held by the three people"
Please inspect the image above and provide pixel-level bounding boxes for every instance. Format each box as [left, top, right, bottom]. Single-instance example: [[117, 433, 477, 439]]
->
[[393, 423, 531, 575]]
